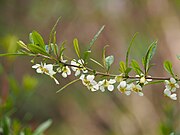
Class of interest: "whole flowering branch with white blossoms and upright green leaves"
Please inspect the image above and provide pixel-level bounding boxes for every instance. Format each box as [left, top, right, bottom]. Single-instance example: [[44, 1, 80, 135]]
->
[[0, 21, 180, 100]]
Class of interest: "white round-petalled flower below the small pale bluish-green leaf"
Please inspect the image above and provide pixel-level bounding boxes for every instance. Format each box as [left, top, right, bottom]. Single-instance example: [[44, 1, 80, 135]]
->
[[98, 79, 116, 92]]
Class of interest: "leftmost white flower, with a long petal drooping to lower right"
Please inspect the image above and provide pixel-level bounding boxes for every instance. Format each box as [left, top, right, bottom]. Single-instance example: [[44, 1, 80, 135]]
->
[[32, 63, 59, 84]]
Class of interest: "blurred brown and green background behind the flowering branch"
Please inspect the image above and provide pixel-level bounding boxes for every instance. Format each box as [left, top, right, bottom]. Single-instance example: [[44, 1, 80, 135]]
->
[[0, 0, 180, 135]]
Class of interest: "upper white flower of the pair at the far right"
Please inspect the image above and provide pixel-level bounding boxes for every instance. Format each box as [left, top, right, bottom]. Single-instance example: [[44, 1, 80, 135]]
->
[[165, 78, 179, 92]]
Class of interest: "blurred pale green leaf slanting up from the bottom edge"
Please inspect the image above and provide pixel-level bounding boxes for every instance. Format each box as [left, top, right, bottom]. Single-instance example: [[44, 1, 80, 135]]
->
[[33, 119, 52, 135]]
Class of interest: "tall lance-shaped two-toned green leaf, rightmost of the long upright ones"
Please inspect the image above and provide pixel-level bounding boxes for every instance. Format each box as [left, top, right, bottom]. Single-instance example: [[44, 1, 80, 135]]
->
[[143, 41, 157, 74]]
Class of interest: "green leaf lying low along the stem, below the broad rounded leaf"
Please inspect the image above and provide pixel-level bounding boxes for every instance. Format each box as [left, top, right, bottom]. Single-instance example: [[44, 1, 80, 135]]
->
[[28, 44, 49, 56]]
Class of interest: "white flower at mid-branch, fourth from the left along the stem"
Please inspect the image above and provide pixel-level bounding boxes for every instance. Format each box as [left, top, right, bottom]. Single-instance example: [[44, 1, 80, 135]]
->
[[80, 74, 99, 91]]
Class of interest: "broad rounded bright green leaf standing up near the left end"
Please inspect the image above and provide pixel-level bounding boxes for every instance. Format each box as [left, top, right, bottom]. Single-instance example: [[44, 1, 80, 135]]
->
[[30, 31, 45, 49]]
